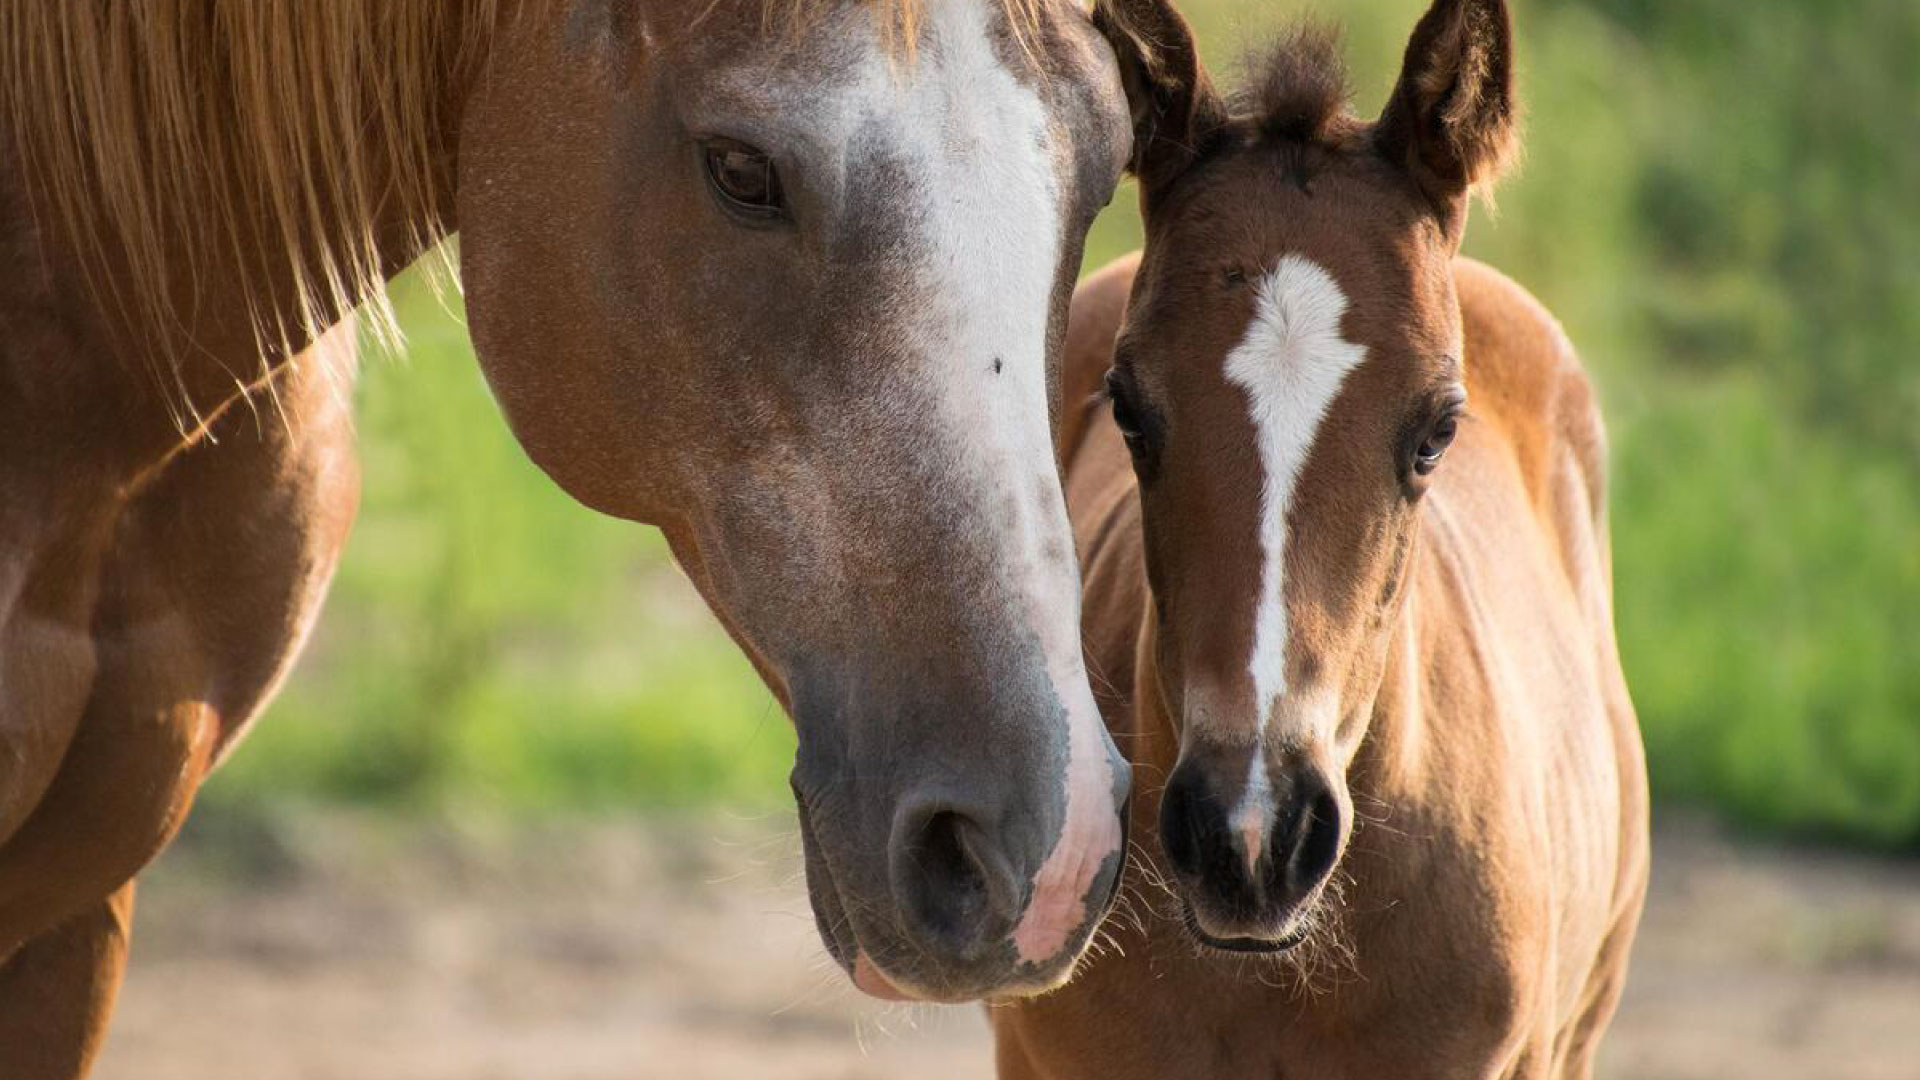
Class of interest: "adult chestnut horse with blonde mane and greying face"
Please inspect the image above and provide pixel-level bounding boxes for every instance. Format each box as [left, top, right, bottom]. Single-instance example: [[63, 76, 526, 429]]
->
[[0, 0, 1129, 1060]]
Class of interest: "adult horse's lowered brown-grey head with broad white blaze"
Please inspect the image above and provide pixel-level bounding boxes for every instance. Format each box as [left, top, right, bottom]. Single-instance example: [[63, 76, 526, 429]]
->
[[461, 0, 1127, 997]]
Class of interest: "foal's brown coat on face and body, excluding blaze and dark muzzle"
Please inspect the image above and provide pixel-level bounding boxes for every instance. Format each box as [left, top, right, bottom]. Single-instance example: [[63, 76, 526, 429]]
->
[[991, 0, 1647, 1080]]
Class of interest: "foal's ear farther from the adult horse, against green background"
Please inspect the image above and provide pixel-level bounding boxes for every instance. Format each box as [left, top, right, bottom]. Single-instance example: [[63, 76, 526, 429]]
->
[[1375, 0, 1519, 233]]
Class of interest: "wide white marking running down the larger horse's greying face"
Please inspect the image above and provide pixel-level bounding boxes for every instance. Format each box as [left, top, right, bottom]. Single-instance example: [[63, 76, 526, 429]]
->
[[768, 0, 1121, 965]]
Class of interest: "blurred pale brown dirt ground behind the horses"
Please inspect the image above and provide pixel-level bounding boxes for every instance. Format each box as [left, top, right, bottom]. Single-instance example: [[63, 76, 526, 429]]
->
[[96, 815, 1920, 1080]]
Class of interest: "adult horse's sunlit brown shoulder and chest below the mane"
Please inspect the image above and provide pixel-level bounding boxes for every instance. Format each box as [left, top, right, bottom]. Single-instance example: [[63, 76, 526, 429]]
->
[[0, 329, 359, 953]]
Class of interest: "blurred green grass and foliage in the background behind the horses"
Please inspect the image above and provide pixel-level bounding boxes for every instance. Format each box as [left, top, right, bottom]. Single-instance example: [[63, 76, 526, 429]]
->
[[207, 0, 1920, 846]]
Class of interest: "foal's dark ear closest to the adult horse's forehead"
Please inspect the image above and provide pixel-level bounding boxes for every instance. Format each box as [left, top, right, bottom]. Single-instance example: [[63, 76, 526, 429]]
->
[[1092, 0, 1227, 202]]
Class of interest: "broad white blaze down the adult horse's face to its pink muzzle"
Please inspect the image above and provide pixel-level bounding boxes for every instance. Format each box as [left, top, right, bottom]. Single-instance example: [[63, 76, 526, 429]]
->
[[902, 0, 1119, 965]]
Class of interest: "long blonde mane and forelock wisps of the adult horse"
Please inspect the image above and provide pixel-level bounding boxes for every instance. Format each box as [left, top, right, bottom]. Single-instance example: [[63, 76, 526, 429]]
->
[[0, 0, 1043, 417]]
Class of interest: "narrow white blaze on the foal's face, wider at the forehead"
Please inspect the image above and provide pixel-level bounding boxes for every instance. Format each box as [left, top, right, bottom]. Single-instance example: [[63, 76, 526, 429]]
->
[[1227, 256, 1367, 822]]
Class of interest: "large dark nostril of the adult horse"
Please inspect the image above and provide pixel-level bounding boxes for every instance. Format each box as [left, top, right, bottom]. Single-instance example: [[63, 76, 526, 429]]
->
[[893, 809, 1020, 955]]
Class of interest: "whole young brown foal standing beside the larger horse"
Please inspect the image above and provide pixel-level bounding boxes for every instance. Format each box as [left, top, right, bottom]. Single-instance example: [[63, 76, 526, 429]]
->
[[993, 0, 1647, 1080]]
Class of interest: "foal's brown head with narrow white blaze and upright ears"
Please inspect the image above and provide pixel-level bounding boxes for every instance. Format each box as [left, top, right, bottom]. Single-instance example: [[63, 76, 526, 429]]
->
[[1102, 0, 1513, 951]]
